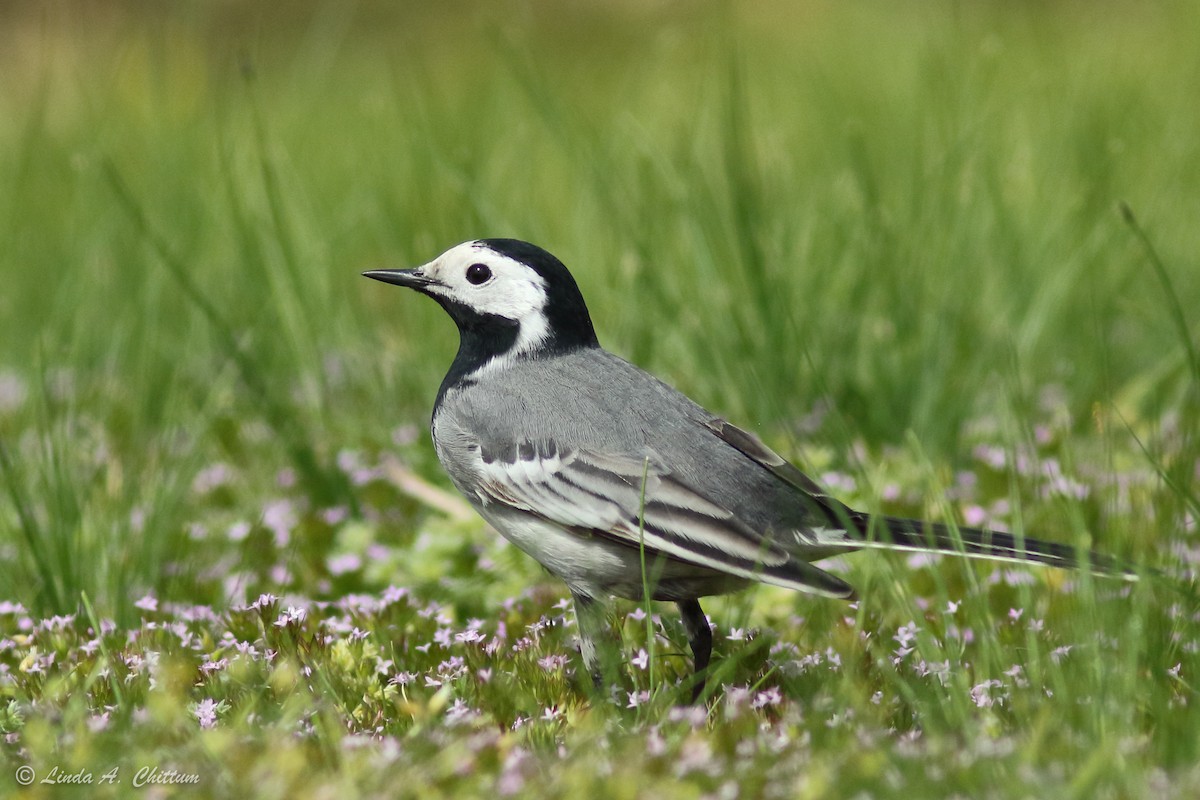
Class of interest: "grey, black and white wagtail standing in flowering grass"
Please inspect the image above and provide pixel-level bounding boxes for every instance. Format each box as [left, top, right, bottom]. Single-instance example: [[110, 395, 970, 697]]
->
[[364, 239, 1124, 699]]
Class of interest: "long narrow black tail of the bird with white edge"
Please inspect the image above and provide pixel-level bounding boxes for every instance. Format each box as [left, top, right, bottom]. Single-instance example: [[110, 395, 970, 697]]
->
[[835, 515, 1138, 581]]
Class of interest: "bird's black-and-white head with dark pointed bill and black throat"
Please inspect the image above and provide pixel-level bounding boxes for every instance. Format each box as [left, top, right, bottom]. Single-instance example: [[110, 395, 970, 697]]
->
[[362, 239, 598, 357]]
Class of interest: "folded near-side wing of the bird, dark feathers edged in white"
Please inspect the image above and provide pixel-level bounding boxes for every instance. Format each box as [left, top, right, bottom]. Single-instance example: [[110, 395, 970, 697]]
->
[[476, 440, 853, 597]]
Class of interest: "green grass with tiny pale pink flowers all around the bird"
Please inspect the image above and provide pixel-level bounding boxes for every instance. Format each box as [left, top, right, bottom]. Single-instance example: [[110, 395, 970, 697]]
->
[[0, 2, 1200, 798]]
